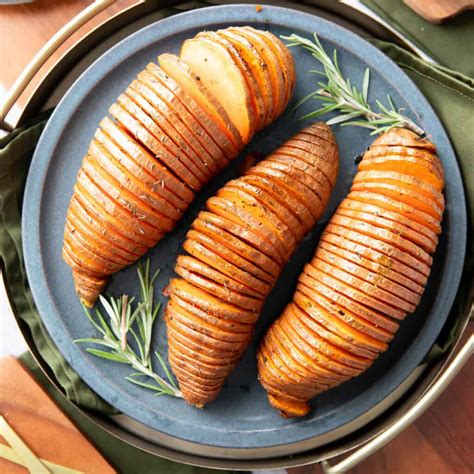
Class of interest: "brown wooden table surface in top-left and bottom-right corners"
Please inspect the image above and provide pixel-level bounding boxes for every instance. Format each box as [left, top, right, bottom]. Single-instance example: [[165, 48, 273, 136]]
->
[[0, 0, 474, 474]]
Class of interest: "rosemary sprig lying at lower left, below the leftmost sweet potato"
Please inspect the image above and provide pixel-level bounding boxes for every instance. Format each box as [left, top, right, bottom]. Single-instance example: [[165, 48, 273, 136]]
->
[[74, 260, 182, 398]]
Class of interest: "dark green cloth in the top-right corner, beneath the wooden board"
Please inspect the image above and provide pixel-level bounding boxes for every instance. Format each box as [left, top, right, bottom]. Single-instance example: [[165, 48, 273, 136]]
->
[[361, 0, 474, 77]]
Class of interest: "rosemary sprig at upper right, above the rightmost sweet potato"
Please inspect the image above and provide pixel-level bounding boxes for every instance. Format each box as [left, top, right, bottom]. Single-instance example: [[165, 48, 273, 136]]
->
[[282, 34, 425, 136]]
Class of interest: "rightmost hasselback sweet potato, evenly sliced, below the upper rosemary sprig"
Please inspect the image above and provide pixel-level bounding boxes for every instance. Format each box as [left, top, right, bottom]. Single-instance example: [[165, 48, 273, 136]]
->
[[257, 129, 444, 417]]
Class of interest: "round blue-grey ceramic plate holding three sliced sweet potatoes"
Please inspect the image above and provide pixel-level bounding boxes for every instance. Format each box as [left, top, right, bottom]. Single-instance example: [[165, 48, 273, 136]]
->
[[23, 5, 466, 448]]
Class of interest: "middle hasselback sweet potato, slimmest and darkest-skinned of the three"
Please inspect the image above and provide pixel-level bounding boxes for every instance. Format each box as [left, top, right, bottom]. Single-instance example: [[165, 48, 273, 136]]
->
[[166, 123, 338, 407]]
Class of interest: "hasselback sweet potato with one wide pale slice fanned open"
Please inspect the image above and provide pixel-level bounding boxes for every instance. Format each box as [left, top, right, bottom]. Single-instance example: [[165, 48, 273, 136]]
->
[[63, 27, 294, 308]]
